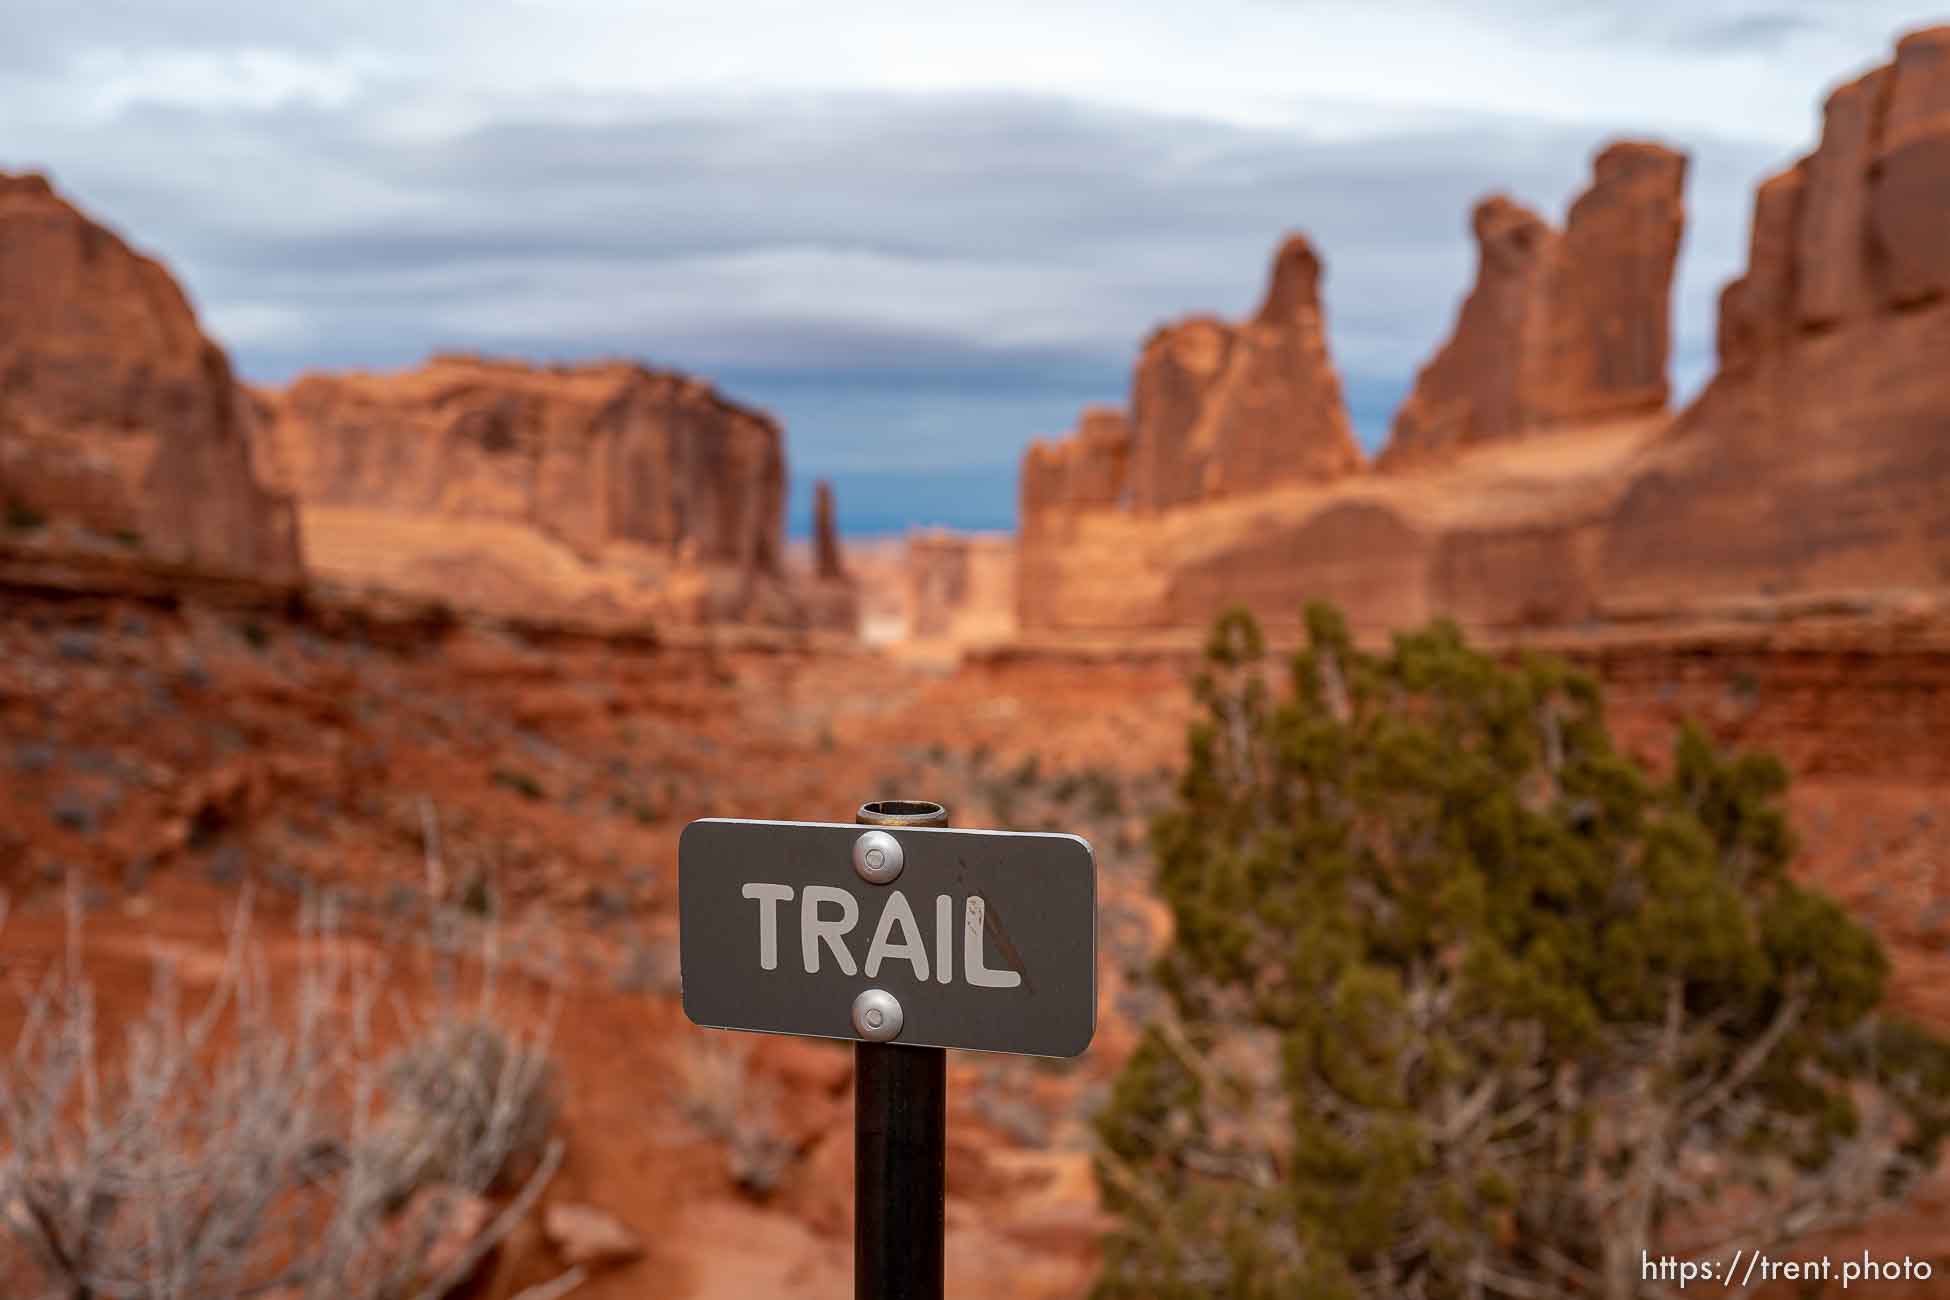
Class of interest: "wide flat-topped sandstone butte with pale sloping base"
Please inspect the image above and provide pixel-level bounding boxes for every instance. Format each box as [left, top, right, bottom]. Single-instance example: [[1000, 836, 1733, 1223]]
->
[[259, 355, 837, 624]]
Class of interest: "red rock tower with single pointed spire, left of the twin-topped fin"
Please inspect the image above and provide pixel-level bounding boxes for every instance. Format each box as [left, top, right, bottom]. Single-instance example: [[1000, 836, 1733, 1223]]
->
[[1131, 236, 1361, 511]]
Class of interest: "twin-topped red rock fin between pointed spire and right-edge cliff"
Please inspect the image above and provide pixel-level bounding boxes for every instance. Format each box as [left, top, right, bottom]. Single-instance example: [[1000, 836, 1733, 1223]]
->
[[1381, 142, 1687, 468]]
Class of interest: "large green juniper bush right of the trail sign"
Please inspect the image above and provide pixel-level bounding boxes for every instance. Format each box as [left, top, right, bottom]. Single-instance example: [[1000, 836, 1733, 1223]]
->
[[1096, 606, 1950, 1300]]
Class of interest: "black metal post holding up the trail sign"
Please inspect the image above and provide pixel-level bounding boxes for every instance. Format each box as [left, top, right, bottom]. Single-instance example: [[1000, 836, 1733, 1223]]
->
[[854, 801, 948, 1300]]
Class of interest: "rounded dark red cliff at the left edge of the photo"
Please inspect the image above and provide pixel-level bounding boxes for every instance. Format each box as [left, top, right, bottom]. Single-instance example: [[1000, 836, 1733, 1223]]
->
[[0, 173, 300, 585]]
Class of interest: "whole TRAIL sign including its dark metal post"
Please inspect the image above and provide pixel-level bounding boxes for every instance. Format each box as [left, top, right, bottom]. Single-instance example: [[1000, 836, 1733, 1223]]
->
[[677, 801, 1096, 1300]]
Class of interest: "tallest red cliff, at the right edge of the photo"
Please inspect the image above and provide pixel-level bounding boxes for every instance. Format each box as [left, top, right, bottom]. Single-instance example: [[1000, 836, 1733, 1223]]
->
[[1603, 27, 1950, 606]]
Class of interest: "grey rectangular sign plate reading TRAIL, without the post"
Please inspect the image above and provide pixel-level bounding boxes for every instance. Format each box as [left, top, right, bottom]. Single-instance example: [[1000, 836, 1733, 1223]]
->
[[677, 817, 1096, 1056]]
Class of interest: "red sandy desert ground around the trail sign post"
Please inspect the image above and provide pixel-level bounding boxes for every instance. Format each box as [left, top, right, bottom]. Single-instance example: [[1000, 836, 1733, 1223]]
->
[[0, 594, 1950, 1298]]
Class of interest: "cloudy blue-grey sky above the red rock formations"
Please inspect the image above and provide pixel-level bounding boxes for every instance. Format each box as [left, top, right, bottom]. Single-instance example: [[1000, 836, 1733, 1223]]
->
[[0, 0, 1946, 532]]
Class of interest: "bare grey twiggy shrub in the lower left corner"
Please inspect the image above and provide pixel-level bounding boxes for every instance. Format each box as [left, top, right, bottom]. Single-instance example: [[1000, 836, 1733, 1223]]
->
[[0, 889, 562, 1300]]
